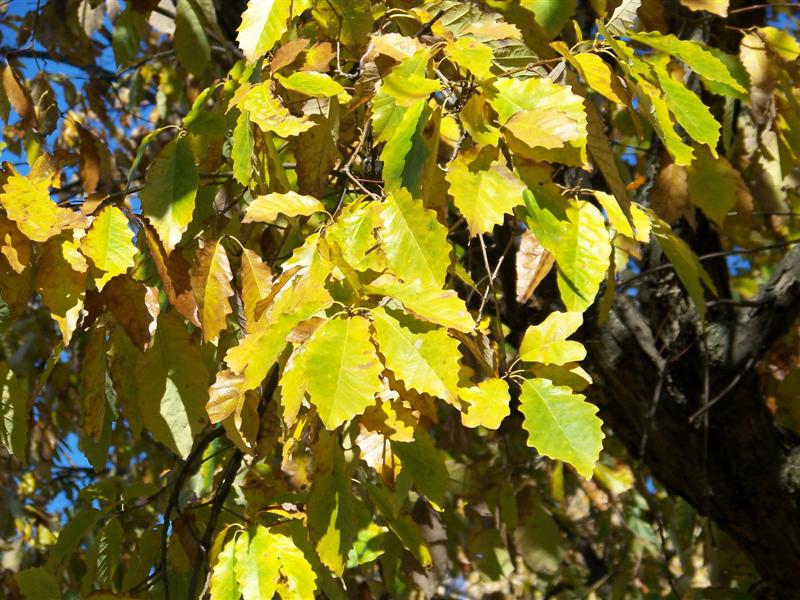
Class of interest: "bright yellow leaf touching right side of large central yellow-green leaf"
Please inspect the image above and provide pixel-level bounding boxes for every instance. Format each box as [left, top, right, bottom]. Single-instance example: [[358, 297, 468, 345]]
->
[[372, 307, 461, 404]]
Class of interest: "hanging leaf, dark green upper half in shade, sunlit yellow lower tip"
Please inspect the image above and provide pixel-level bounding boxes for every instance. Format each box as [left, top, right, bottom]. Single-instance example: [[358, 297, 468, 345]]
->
[[139, 136, 198, 254]]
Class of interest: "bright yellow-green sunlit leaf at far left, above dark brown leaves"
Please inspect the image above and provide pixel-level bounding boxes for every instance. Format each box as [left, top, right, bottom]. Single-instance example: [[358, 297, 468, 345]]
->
[[80, 205, 139, 290]]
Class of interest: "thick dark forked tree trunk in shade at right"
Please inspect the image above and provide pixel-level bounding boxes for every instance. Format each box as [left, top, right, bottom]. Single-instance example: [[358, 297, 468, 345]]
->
[[586, 248, 800, 598]]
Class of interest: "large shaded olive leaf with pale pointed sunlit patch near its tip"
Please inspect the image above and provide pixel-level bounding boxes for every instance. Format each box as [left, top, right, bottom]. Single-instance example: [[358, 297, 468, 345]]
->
[[136, 312, 209, 457]]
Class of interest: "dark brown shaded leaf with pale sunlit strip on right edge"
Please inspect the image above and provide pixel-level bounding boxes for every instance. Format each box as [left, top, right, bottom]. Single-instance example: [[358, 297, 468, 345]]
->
[[102, 275, 161, 352]]
